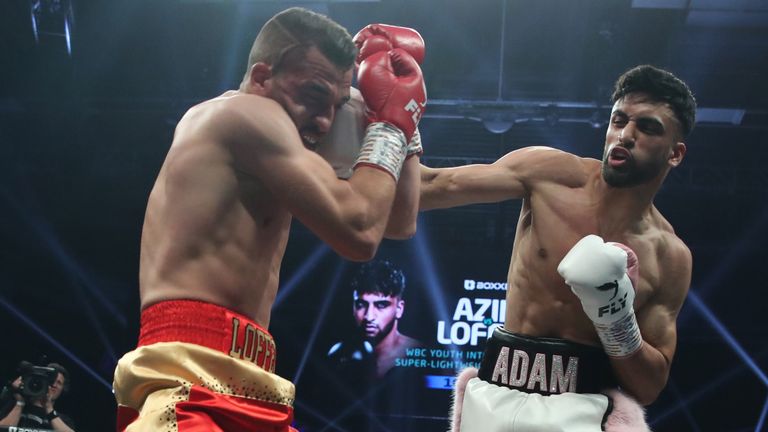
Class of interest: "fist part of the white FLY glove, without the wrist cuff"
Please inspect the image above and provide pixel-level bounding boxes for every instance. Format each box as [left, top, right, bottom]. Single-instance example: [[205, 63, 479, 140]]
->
[[557, 235, 637, 324]]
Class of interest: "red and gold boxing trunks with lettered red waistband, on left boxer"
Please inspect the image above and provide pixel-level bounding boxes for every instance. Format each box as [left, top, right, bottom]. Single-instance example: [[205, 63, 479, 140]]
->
[[113, 300, 295, 432]]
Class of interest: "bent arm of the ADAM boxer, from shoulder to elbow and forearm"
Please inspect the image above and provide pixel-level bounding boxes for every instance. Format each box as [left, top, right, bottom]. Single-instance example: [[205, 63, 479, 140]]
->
[[611, 241, 691, 405]]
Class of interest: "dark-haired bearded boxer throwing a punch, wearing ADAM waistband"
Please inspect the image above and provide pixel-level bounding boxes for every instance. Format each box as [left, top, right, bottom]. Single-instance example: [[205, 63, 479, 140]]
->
[[421, 66, 696, 432]]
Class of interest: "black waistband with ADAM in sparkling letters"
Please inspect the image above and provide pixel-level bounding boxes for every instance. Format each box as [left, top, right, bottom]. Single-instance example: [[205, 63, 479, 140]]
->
[[478, 327, 617, 395]]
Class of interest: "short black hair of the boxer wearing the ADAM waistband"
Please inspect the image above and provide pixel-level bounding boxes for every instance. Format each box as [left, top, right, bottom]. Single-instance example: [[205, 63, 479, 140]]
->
[[611, 65, 696, 136]]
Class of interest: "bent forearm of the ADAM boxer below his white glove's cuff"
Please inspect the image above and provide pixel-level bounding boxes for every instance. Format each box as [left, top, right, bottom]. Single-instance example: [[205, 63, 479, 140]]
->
[[611, 342, 670, 405]]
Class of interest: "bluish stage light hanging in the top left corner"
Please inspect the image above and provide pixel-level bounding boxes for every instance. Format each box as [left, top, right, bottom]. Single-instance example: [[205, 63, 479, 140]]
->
[[29, 0, 74, 56]]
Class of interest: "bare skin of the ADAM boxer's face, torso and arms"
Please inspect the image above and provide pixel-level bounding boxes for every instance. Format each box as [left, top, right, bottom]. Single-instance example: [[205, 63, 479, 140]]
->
[[421, 93, 691, 404]]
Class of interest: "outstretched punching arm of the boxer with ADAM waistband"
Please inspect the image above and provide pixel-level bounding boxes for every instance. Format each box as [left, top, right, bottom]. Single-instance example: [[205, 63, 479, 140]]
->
[[420, 147, 581, 210]]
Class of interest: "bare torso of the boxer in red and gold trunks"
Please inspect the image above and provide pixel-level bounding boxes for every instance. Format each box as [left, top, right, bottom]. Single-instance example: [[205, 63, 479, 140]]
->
[[139, 92, 291, 325]]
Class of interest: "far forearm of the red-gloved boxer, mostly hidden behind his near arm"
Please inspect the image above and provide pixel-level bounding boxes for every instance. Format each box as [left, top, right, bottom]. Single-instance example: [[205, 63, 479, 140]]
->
[[384, 156, 421, 240]]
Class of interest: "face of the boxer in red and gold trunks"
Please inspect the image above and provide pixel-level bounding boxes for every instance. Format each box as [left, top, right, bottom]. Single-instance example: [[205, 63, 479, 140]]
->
[[265, 47, 352, 150]]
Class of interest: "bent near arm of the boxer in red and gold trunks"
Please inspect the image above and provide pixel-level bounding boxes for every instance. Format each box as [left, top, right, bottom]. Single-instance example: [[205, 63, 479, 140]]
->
[[219, 96, 396, 260]]
